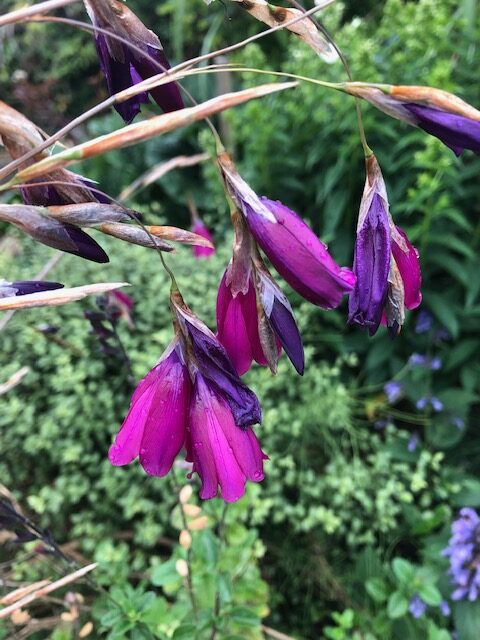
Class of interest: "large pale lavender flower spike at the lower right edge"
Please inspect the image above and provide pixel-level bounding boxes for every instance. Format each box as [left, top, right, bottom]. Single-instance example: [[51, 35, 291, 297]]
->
[[442, 508, 480, 602]]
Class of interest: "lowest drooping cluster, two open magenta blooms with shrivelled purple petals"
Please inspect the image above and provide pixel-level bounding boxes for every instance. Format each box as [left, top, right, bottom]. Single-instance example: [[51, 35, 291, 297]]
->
[[109, 291, 265, 502]]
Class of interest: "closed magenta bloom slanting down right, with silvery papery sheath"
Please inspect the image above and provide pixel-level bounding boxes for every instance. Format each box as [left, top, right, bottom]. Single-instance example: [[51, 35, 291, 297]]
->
[[218, 153, 355, 309]]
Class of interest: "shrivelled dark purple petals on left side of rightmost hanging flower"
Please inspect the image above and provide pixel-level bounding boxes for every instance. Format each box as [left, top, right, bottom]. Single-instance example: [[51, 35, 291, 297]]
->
[[348, 192, 391, 336]]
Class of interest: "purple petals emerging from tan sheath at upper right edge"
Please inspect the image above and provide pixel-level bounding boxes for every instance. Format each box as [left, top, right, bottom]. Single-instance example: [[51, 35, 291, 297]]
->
[[403, 103, 480, 156]]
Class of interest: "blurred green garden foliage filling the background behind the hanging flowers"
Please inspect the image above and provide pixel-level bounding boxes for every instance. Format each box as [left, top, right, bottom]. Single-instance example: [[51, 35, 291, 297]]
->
[[0, 0, 480, 640]]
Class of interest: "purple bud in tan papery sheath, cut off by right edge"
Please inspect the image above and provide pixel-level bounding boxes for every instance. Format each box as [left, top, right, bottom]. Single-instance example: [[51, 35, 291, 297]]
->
[[343, 82, 480, 156]]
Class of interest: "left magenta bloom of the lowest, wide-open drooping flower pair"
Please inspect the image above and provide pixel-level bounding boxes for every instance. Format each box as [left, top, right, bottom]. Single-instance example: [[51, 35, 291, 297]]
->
[[108, 349, 190, 476]]
